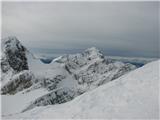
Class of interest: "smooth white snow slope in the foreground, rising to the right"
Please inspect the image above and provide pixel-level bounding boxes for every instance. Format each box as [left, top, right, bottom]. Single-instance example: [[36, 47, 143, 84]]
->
[[4, 60, 160, 119]]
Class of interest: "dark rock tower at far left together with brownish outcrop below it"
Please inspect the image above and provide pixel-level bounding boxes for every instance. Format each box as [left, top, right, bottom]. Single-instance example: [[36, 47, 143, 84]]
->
[[0, 37, 34, 94]]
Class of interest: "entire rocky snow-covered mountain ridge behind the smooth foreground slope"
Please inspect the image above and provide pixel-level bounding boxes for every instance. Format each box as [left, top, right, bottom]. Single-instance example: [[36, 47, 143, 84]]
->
[[1, 37, 136, 115]]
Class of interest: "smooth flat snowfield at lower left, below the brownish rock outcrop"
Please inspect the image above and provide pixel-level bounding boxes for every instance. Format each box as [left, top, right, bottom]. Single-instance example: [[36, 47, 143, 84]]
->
[[1, 88, 48, 115]]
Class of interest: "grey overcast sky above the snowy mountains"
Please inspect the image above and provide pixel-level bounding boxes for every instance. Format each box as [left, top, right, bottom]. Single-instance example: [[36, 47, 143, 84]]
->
[[2, 2, 159, 57]]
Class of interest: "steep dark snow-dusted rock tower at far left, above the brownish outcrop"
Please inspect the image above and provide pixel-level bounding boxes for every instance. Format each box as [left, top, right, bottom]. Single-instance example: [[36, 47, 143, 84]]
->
[[1, 37, 29, 72]]
